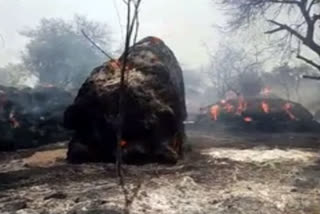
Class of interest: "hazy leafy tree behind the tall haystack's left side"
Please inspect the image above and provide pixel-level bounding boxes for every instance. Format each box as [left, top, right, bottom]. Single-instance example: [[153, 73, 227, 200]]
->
[[21, 16, 110, 88]]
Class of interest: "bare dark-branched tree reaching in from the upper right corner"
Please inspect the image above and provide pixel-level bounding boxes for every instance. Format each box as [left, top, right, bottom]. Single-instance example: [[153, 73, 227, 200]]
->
[[219, 0, 320, 71]]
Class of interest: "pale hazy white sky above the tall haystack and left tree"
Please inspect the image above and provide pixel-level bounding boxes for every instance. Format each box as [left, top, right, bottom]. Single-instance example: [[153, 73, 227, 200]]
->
[[0, 0, 222, 67]]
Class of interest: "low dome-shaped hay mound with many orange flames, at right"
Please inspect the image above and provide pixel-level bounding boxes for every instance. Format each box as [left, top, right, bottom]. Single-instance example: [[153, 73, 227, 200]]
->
[[196, 97, 320, 132]]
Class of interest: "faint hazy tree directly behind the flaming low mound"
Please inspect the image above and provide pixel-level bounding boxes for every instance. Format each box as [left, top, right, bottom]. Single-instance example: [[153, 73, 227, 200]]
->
[[209, 45, 262, 98]]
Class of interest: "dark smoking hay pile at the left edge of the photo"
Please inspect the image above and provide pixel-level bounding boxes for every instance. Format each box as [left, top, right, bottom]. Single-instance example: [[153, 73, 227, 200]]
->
[[0, 86, 72, 150]]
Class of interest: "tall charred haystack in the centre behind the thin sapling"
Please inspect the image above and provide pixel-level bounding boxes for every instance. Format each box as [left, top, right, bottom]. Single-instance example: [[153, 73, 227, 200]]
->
[[65, 37, 186, 163]]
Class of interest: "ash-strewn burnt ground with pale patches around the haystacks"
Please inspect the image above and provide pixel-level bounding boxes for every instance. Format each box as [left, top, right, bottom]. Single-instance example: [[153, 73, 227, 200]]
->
[[0, 132, 320, 214]]
